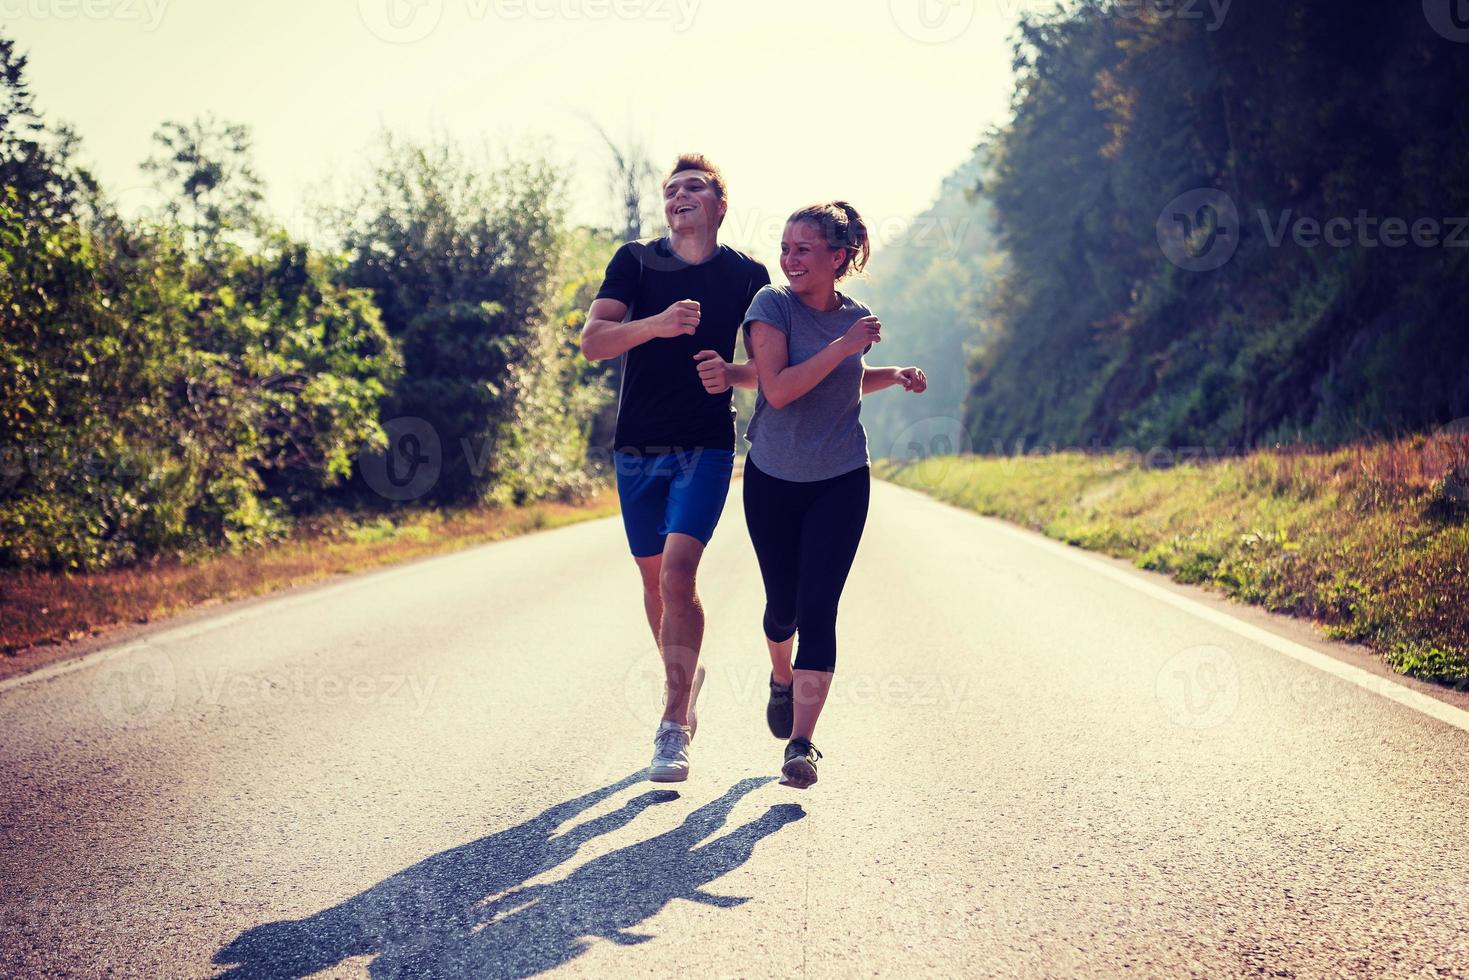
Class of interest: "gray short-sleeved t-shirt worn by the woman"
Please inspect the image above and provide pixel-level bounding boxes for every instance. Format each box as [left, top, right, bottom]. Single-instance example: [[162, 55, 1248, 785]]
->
[[745, 285, 873, 483]]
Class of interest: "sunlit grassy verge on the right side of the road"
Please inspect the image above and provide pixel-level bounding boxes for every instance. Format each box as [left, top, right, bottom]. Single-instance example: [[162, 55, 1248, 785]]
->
[[876, 433, 1469, 689]]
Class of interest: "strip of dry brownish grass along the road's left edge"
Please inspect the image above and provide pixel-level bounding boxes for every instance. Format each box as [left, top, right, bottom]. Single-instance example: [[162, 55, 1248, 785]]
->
[[0, 491, 617, 657]]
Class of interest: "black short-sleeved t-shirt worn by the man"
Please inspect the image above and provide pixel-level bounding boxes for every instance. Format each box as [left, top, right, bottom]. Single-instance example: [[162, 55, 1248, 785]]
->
[[596, 238, 770, 454]]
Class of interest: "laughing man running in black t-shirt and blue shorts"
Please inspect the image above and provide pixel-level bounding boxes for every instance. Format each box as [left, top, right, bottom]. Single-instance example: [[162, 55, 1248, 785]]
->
[[582, 154, 770, 782]]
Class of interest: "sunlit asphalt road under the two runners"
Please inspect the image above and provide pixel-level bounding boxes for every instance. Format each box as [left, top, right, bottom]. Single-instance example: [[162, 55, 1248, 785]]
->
[[0, 485, 1469, 977]]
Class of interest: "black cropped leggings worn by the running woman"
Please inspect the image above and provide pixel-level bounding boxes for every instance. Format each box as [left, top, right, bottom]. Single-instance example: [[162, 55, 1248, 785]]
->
[[745, 458, 871, 673]]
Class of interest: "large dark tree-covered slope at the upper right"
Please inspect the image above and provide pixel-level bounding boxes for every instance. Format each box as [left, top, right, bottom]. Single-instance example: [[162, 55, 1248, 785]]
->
[[965, 0, 1469, 448]]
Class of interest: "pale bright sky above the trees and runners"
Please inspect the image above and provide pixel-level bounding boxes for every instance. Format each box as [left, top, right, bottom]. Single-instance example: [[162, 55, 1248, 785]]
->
[[0, 0, 1034, 262]]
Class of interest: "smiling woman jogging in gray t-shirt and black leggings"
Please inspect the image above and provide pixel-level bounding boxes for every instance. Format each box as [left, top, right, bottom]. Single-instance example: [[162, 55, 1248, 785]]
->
[[745, 201, 928, 789]]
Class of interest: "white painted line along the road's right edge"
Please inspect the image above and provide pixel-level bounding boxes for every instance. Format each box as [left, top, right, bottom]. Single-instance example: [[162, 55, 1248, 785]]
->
[[899, 486, 1469, 732]]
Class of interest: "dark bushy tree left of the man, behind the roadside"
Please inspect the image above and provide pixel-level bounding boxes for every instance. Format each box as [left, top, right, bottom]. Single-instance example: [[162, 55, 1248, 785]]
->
[[338, 134, 564, 502]]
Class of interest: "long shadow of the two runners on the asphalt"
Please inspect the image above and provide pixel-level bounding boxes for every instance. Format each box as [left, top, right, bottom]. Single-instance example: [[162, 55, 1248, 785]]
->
[[214, 773, 805, 980]]
